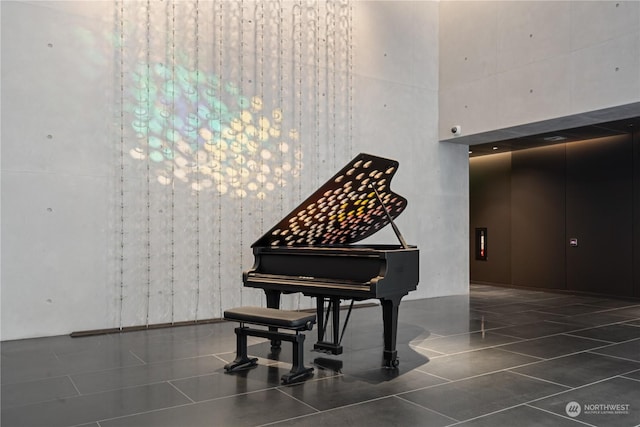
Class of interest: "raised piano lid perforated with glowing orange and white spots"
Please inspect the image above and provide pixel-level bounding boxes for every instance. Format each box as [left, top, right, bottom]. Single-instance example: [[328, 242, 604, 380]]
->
[[252, 153, 407, 247]]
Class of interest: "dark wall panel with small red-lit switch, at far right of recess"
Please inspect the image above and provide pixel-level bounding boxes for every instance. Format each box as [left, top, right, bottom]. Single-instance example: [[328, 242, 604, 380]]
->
[[566, 135, 633, 296]]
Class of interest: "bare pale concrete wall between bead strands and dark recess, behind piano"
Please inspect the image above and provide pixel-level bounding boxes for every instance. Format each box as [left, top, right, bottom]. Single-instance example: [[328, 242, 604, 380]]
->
[[354, 1, 469, 299]]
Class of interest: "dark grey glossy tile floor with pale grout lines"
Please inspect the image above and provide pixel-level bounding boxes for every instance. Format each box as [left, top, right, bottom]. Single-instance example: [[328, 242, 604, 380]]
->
[[1, 285, 640, 427]]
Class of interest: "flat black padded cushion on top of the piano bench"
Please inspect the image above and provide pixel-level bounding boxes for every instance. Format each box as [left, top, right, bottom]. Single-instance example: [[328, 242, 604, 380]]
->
[[224, 307, 316, 329]]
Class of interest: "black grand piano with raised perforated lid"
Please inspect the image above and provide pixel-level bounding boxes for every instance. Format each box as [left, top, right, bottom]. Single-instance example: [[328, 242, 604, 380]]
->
[[243, 153, 419, 368]]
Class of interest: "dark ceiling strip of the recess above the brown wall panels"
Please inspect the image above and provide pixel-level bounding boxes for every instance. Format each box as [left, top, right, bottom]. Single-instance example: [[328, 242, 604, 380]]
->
[[469, 116, 640, 157]]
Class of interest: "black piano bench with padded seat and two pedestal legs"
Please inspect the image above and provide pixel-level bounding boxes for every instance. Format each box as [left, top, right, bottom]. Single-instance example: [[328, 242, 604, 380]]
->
[[224, 307, 316, 384]]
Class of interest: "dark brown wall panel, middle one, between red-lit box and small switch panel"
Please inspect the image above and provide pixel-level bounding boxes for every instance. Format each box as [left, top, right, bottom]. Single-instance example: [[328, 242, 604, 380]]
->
[[511, 144, 565, 289]]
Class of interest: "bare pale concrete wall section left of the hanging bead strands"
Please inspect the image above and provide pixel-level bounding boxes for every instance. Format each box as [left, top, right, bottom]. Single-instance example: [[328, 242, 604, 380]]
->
[[1, 2, 115, 340]]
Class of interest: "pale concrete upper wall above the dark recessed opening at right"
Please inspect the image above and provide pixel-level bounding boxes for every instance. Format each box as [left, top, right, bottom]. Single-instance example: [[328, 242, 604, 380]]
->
[[439, 1, 640, 139]]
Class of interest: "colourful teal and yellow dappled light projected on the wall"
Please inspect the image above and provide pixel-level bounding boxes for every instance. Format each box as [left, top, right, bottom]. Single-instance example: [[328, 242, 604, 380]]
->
[[127, 63, 303, 199]]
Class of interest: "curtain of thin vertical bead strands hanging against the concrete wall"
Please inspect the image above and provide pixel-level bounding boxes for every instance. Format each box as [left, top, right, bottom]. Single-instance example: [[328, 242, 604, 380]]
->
[[110, 0, 353, 328]]
